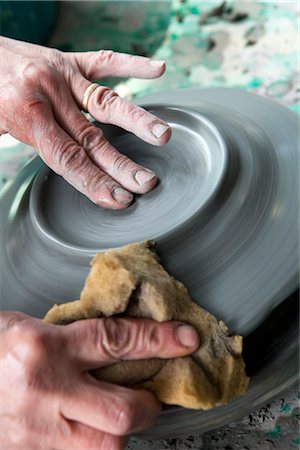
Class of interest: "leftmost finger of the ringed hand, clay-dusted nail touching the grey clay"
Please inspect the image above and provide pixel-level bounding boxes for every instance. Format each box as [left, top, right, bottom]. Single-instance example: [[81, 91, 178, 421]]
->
[[32, 96, 133, 209]]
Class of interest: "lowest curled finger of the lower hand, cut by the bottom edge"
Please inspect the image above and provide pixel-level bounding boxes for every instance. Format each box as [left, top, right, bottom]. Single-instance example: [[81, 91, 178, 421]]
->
[[56, 418, 128, 450]]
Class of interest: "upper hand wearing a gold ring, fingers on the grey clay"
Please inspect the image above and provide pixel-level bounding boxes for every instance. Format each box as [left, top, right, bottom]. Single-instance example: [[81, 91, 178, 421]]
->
[[0, 37, 171, 209]]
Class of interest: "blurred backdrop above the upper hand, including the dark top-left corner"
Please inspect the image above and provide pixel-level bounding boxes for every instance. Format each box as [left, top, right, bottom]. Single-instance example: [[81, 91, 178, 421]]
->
[[1, 0, 299, 104]]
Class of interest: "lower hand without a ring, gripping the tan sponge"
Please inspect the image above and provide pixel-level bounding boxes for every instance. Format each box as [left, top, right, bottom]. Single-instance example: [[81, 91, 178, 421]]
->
[[0, 313, 199, 450]]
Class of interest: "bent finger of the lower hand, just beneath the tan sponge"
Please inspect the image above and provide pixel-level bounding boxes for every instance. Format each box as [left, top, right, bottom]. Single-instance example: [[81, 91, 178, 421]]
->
[[60, 373, 160, 436]]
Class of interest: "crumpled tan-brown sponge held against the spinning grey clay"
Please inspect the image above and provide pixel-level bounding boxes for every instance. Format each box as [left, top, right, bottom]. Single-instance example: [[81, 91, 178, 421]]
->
[[44, 241, 248, 410]]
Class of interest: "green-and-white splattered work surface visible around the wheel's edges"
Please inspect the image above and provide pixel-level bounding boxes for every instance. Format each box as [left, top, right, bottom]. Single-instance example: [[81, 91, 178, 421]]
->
[[1, 1, 299, 450]]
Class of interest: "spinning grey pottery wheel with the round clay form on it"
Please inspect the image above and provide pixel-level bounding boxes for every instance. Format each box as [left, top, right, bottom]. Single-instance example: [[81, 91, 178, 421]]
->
[[0, 89, 299, 438]]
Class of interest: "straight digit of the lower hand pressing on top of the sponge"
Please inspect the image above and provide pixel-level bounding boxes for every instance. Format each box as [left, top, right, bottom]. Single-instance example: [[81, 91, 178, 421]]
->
[[63, 318, 199, 369]]
